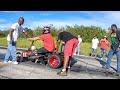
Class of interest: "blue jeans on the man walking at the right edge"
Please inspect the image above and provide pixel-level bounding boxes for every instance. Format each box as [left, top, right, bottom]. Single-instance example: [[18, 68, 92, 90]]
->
[[106, 48, 120, 72]]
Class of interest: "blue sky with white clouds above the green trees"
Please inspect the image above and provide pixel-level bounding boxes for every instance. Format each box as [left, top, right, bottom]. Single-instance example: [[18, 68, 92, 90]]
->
[[0, 11, 120, 30]]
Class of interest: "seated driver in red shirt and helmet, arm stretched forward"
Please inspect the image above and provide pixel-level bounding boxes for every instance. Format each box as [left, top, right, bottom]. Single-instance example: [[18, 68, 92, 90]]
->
[[29, 26, 55, 58]]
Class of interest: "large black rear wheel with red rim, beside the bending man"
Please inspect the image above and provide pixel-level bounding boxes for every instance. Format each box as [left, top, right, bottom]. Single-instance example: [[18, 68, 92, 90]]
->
[[47, 54, 63, 69]]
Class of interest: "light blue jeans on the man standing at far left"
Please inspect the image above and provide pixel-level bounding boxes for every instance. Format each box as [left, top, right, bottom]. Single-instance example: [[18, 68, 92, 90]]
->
[[4, 41, 16, 62]]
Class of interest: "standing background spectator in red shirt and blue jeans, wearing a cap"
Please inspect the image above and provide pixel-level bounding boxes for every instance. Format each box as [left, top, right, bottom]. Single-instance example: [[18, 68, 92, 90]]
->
[[100, 36, 108, 60]]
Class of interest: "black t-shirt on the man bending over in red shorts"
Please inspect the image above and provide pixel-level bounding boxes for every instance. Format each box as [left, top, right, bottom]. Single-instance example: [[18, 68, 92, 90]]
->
[[58, 31, 77, 43]]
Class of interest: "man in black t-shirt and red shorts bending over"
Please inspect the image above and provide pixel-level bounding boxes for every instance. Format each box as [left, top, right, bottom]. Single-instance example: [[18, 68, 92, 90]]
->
[[55, 30, 78, 76]]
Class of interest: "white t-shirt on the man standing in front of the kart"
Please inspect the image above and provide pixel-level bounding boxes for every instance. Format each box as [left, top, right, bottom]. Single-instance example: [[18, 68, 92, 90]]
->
[[7, 23, 25, 41]]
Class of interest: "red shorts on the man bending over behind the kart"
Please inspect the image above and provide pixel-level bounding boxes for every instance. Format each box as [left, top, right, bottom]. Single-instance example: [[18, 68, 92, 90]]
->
[[64, 38, 79, 56]]
